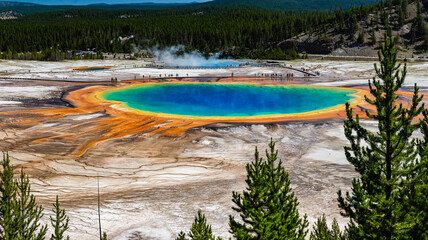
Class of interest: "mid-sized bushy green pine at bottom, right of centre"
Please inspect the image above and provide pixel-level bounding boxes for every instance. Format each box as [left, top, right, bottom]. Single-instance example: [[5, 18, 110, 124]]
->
[[229, 140, 308, 240]]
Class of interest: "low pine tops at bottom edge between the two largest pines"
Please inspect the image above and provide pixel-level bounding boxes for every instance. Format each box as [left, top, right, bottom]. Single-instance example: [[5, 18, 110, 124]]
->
[[310, 214, 347, 240]]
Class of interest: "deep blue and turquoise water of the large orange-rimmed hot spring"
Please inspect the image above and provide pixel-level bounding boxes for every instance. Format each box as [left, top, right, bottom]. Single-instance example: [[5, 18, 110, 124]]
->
[[103, 83, 356, 117]]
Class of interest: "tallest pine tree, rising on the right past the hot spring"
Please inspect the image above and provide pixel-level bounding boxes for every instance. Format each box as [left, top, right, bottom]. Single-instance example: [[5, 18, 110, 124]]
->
[[338, 31, 423, 239]]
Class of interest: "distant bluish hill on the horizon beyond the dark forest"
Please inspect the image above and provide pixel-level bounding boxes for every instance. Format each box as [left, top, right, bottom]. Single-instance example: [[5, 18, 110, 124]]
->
[[205, 0, 378, 11]]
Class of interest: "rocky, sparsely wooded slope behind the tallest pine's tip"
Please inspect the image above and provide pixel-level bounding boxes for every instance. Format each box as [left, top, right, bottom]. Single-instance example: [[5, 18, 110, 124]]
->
[[279, 0, 428, 57]]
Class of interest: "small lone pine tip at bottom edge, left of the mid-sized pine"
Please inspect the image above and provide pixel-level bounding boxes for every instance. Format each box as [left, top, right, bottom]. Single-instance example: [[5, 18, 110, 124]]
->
[[176, 210, 221, 240]]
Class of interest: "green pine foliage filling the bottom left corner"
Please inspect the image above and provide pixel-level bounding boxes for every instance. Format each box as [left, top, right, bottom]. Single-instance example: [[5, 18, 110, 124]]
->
[[0, 155, 47, 240]]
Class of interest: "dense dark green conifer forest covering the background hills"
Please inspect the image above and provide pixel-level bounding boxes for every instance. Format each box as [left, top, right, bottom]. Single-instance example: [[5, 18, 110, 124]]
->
[[0, 0, 426, 60]]
